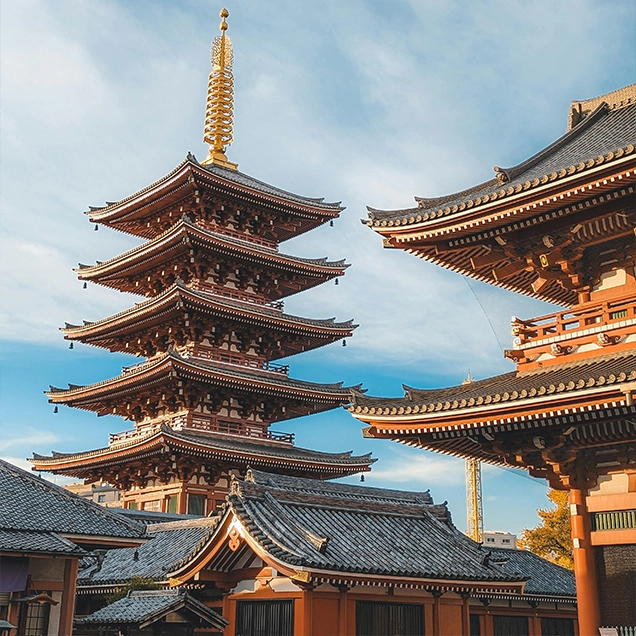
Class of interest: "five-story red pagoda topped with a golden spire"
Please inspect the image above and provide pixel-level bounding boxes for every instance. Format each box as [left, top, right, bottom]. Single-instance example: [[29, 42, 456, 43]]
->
[[32, 9, 373, 514]]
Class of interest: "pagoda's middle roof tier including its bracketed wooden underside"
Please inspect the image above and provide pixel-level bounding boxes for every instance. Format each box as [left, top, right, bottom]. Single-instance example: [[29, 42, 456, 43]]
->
[[62, 281, 357, 359]]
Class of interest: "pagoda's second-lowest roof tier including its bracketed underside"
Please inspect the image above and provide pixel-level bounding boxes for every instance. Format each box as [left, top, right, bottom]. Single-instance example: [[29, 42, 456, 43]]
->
[[46, 349, 351, 420]]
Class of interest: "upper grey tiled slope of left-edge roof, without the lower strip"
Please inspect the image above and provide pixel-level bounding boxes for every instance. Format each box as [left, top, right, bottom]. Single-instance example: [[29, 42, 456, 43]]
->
[[0, 460, 144, 545]]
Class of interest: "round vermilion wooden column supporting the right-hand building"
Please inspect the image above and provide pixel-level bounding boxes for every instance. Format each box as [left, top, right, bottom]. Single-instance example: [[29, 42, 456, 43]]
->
[[569, 488, 601, 636]]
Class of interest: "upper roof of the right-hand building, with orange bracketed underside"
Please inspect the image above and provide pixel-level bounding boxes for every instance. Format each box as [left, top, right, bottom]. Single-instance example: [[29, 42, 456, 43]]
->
[[363, 84, 636, 305]]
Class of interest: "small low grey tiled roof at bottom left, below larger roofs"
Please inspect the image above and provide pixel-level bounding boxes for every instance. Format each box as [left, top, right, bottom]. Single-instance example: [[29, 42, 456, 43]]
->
[[75, 589, 228, 631]]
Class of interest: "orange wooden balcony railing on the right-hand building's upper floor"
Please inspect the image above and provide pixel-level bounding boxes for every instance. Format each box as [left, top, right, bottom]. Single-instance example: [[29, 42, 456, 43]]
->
[[511, 296, 636, 348]]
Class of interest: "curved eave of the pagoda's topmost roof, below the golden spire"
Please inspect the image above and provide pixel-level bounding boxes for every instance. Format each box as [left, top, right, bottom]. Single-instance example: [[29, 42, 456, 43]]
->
[[86, 158, 344, 228]]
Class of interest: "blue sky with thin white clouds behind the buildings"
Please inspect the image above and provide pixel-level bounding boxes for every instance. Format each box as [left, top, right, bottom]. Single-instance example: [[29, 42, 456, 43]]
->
[[0, 0, 636, 532]]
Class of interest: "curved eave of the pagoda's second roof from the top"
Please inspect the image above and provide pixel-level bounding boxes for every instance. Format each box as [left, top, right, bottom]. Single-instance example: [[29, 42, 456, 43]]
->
[[74, 219, 349, 284]]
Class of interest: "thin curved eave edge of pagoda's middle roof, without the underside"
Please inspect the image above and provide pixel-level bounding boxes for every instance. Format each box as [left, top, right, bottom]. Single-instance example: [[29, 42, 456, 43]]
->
[[61, 284, 357, 344]]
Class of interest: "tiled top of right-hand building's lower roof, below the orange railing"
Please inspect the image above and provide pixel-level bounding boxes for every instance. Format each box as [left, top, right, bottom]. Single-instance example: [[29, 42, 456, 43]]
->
[[349, 350, 636, 416]]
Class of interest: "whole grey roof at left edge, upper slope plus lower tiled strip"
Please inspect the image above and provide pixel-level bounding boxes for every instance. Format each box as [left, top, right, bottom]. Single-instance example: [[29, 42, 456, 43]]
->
[[0, 460, 144, 554]]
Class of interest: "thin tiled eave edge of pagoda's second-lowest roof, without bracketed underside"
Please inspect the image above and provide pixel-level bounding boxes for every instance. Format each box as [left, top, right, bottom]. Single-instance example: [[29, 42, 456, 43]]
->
[[45, 353, 350, 410]]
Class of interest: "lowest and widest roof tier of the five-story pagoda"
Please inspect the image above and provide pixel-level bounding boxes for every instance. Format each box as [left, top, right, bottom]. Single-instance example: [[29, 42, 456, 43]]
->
[[29, 424, 376, 479]]
